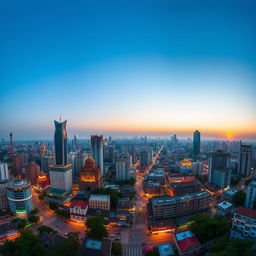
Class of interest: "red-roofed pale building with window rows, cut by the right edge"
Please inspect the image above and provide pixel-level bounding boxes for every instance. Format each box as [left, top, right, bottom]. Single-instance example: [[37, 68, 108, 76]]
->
[[230, 207, 256, 239]]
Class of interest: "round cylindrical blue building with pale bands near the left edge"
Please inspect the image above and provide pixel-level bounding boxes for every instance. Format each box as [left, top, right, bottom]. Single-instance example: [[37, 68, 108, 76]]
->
[[7, 179, 33, 215]]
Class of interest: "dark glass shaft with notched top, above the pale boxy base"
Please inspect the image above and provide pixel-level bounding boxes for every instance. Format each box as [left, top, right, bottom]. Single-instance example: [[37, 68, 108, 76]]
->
[[54, 120, 68, 165]]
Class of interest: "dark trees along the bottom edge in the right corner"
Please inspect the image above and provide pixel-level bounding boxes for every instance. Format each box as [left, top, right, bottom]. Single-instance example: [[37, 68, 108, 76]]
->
[[209, 237, 254, 256]]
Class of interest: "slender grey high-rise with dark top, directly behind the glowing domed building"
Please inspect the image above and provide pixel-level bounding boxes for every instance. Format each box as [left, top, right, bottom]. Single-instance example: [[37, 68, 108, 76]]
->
[[91, 135, 104, 175]]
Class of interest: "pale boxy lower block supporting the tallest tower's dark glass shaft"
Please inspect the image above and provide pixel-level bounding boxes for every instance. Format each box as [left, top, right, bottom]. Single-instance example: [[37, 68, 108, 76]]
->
[[50, 164, 73, 192]]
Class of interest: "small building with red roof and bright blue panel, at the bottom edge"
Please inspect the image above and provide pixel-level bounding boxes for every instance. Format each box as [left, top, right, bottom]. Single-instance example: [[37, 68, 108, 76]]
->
[[174, 230, 201, 256]]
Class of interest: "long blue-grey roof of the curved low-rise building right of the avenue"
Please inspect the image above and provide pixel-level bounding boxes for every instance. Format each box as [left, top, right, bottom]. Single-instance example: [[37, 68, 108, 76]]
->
[[152, 191, 210, 205]]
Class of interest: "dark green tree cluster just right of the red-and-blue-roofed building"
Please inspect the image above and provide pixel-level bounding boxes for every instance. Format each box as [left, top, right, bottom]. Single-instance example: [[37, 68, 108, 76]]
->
[[190, 214, 231, 243]]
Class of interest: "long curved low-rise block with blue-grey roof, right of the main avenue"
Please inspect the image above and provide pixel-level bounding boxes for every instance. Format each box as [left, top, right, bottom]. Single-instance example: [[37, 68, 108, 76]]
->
[[150, 191, 210, 219]]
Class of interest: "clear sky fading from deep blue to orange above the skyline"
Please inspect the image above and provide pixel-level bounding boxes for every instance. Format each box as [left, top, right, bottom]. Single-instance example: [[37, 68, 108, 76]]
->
[[0, 0, 256, 140]]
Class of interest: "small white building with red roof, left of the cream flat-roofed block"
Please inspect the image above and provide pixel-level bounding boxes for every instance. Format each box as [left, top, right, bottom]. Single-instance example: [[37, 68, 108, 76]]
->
[[69, 200, 88, 222]]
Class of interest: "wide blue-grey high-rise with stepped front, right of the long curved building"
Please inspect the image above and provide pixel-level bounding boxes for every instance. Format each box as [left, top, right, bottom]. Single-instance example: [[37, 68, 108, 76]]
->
[[208, 150, 231, 189]]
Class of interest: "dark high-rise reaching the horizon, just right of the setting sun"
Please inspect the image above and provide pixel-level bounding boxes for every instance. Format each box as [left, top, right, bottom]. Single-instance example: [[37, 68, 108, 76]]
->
[[238, 144, 252, 177]]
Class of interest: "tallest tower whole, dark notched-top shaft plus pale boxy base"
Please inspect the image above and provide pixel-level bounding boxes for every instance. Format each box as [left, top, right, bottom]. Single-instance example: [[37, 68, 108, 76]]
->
[[50, 121, 73, 192]]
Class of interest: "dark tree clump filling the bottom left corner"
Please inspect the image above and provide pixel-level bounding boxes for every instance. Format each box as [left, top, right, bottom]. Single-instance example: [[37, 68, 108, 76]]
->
[[0, 230, 44, 256]]
